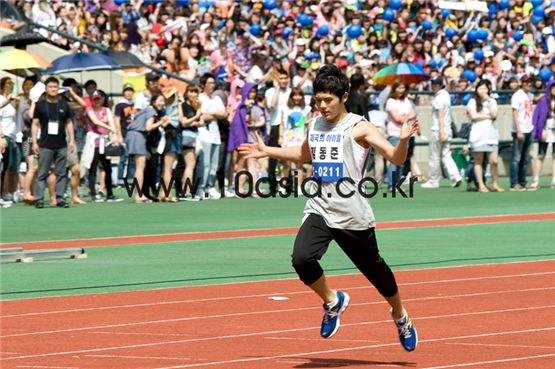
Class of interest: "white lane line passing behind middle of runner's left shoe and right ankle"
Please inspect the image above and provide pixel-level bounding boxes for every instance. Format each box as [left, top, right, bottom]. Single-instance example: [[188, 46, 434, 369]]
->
[[0, 287, 555, 339]]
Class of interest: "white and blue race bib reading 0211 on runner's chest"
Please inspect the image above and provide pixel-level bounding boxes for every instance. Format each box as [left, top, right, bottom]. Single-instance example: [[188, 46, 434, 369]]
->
[[308, 130, 343, 182]]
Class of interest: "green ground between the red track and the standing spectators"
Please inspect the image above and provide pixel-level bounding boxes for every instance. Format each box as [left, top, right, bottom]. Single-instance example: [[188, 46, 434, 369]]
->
[[0, 180, 555, 300]]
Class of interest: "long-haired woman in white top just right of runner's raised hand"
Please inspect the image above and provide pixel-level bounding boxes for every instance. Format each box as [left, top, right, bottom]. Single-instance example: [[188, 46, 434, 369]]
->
[[385, 81, 416, 189]]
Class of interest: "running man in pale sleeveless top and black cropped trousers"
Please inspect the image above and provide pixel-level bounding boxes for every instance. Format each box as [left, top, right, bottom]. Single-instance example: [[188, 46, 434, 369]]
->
[[239, 65, 418, 351]]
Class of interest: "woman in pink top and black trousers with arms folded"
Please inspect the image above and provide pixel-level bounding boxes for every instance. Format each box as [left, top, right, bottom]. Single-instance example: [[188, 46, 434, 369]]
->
[[86, 90, 123, 202]]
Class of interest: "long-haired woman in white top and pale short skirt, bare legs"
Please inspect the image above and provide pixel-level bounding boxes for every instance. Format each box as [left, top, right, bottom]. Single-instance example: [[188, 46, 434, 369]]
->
[[466, 79, 505, 192]]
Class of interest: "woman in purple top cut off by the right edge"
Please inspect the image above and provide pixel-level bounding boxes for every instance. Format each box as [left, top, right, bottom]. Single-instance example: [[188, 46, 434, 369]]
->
[[530, 79, 555, 190]]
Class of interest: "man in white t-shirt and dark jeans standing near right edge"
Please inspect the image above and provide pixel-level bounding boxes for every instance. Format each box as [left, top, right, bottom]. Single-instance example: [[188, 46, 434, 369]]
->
[[509, 75, 534, 191]]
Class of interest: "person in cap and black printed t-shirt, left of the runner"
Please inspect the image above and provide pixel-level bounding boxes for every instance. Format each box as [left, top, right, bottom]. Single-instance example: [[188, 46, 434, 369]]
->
[[114, 83, 137, 186]]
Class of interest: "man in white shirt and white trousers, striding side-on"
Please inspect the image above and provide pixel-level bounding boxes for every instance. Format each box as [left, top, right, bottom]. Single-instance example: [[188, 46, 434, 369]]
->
[[422, 77, 462, 188]]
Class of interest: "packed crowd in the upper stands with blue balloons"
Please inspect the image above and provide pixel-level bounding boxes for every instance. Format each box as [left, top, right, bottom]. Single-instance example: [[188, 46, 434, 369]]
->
[[6, 0, 555, 103]]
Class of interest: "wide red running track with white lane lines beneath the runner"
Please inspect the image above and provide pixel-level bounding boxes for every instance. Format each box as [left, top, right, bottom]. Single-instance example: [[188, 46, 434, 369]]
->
[[0, 261, 555, 369]]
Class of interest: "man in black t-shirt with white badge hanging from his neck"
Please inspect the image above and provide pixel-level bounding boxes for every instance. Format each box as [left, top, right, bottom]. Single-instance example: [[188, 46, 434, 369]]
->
[[31, 77, 75, 209]]
